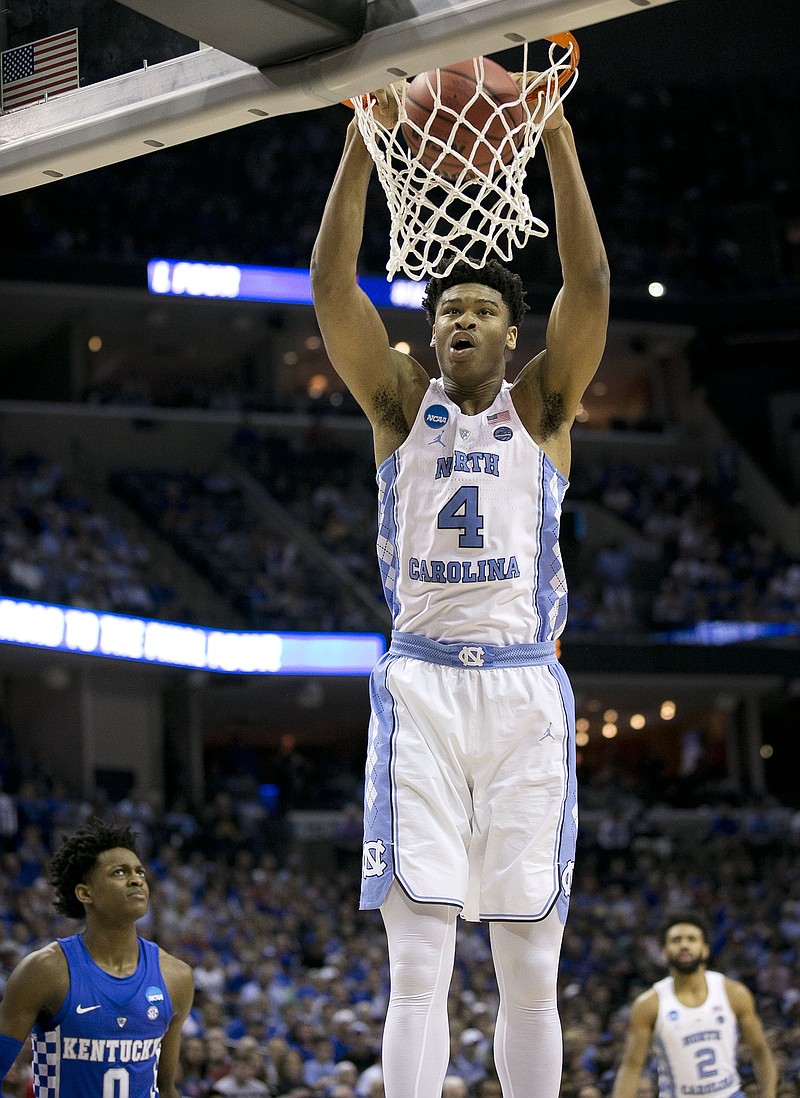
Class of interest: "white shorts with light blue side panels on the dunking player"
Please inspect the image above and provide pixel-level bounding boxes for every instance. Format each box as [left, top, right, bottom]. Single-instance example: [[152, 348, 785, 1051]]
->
[[361, 642, 577, 922]]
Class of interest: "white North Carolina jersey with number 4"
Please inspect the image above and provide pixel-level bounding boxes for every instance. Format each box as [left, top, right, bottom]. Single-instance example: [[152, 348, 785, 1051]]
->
[[378, 378, 567, 645]]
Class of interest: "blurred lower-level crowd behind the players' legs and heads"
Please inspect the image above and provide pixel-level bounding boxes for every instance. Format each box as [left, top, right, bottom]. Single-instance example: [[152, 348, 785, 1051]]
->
[[0, 755, 800, 1098]]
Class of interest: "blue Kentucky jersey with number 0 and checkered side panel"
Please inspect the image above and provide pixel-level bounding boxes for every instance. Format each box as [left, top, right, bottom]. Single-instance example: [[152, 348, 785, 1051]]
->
[[32, 934, 172, 1098]]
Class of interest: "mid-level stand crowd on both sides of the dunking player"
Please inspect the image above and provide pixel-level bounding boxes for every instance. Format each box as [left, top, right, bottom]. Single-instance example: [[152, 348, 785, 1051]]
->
[[0, 430, 800, 636]]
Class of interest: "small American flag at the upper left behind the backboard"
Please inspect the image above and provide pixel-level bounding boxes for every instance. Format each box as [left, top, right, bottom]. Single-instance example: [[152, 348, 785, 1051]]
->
[[0, 27, 78, 111]]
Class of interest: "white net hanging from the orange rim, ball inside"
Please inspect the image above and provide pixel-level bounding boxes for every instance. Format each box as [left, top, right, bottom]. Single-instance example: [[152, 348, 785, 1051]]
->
[[352, 35, 577, 280]]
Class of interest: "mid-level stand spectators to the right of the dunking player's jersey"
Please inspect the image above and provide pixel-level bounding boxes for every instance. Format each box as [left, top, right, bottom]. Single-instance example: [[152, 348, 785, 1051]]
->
[[570, 448, 800, 632]]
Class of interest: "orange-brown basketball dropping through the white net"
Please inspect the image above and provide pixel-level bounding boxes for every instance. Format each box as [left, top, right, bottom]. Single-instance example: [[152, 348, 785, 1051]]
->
[[403, 57, 525, 179]]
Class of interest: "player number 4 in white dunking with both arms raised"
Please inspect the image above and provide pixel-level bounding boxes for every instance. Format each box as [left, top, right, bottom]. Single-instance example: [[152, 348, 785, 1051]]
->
[[312, 75, 609, 1098]]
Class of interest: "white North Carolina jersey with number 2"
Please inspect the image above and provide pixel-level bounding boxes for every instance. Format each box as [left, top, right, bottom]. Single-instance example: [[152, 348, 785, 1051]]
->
[[653, 972, 742, 1098]]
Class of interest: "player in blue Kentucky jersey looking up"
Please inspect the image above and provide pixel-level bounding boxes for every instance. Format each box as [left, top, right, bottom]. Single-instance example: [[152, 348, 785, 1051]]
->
[[0, 820, 194, 1098]]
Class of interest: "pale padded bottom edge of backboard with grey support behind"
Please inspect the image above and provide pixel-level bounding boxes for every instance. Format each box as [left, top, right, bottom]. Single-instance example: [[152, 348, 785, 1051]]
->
[[0, 0, 674, 194]]
